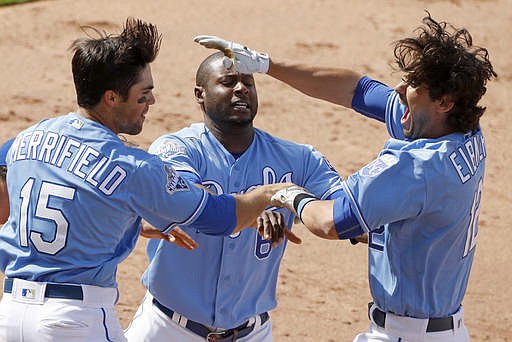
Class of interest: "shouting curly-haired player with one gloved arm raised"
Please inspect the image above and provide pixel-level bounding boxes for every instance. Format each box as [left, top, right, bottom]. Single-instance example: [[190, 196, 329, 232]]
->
[[196, 10, 497, 341]]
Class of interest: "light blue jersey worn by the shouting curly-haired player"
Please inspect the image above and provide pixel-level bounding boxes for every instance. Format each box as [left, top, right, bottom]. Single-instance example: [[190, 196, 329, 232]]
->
[[343, 78, 486, 318]]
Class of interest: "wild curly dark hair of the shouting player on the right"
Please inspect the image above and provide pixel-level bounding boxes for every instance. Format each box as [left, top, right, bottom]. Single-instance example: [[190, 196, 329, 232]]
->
[[394, 11, 497, 132]]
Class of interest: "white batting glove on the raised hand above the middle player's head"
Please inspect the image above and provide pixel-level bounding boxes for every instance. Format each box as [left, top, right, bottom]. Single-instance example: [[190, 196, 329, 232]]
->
[[194, 36, 270, 74]]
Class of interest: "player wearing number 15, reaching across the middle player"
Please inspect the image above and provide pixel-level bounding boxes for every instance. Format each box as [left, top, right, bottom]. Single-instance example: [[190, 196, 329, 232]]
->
[[0, 18, 290, 342]]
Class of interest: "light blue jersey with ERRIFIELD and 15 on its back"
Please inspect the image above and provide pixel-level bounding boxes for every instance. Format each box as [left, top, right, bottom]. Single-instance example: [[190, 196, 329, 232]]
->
[[0, 113, 234, 287]]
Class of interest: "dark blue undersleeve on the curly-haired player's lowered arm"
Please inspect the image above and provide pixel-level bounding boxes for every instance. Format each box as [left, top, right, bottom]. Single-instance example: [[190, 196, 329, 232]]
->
[[333, 188, 364, 239]]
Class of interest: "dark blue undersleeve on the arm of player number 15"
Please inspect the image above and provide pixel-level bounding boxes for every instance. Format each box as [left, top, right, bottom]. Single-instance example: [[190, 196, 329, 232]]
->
[[184, 194, 236, 236]]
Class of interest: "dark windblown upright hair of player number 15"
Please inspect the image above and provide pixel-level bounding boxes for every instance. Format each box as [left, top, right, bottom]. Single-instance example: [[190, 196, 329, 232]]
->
[[71, 17, 162, 109]]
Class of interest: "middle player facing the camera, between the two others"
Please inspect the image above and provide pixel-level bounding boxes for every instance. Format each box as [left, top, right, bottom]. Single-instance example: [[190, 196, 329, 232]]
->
[[126, 52, 341, 342]]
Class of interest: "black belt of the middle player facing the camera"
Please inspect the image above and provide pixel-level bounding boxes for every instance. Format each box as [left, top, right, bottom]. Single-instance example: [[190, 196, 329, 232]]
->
[[153, 298, 270, 341]]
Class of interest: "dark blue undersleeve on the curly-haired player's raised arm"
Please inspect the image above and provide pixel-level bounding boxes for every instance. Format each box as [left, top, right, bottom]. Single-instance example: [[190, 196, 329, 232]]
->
[[352, 76, 393, 122]]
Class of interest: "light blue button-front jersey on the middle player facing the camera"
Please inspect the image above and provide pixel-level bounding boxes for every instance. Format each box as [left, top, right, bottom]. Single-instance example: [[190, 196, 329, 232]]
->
[[143, 123, 341, 328]]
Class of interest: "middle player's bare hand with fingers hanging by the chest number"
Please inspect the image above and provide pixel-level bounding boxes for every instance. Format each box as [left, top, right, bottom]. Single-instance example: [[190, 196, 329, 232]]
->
[[256, 210, 302, 248]]
